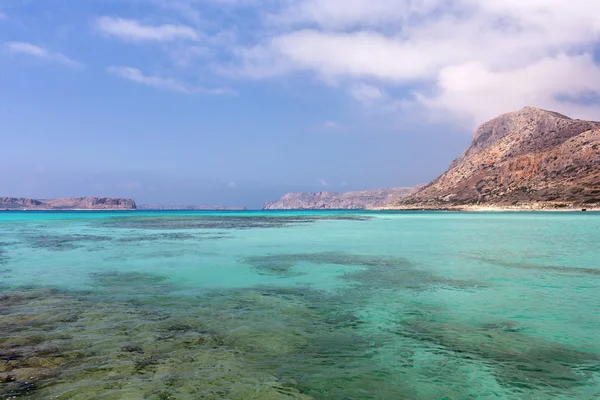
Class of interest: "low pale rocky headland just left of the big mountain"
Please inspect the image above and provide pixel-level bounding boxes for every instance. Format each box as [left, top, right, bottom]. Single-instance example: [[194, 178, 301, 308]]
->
[[263, 186, 420, 210]]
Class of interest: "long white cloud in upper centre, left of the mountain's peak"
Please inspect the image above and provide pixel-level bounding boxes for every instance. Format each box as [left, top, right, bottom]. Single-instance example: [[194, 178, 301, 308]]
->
[[232, 30, 442, 82]]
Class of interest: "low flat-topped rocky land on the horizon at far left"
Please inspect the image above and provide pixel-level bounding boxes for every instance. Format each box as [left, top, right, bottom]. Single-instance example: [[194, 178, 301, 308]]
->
[[0, 197, 136, 210]]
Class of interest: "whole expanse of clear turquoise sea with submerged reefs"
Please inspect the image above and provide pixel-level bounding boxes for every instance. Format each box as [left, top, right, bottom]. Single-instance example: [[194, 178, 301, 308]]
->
[[0, 211, 600, 399]]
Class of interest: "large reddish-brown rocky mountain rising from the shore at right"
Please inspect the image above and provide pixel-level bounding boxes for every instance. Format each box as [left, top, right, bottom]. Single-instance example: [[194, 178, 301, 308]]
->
[[388, 107, 600, 209]]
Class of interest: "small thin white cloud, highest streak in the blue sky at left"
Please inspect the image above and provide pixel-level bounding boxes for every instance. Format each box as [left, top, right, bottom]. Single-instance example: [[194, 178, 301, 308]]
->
[[95, 16, 200, 42]]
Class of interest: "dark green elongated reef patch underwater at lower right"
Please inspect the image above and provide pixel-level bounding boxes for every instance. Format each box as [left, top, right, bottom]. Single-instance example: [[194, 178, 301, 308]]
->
[[397, 320, 600, 390]]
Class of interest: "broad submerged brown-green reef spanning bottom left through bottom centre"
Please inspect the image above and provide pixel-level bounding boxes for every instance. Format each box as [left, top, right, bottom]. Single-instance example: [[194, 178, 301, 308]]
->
[[0, 282, 407, 400]]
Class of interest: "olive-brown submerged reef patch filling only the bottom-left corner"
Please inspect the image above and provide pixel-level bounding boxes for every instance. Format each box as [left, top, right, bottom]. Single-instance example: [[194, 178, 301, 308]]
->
[[0, 288, 318, 400]]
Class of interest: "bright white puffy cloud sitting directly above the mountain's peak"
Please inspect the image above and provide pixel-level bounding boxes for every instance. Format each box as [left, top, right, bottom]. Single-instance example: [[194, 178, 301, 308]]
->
[[419, 54, 600, 126]]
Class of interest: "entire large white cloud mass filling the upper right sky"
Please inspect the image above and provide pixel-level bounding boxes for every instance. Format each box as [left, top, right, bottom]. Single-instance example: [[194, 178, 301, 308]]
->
[[223, 0, 600, 125]]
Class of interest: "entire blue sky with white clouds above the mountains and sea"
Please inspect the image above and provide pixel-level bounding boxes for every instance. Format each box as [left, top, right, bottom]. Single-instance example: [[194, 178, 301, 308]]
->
[[0, 0, 600, 208]]
